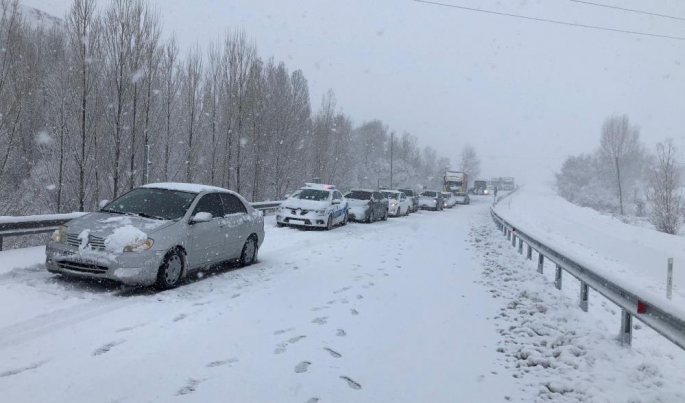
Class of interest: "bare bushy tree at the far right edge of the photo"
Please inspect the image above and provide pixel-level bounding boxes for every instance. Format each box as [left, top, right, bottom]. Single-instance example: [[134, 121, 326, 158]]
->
[[648, 139, 683, 235]]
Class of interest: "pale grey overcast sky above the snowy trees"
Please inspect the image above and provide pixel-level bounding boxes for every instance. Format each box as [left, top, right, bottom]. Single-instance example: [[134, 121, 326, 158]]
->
[[23, 0, 685, 182]]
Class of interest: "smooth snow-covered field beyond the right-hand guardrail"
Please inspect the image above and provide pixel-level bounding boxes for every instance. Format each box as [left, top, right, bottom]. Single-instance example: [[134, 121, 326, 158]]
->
[[498, 186, 685, 312]]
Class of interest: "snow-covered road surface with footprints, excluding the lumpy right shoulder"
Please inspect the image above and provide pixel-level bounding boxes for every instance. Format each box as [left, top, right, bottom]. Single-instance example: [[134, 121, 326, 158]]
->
[[0, 200, 515, 402]]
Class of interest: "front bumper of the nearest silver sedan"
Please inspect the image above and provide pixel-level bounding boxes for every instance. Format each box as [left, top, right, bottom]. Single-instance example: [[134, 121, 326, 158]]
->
[[45, 242, 165, 286]]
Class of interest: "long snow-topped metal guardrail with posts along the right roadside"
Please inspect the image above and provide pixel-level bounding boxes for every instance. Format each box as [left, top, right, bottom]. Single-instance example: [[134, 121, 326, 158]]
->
[[490, 207, 685, 349]]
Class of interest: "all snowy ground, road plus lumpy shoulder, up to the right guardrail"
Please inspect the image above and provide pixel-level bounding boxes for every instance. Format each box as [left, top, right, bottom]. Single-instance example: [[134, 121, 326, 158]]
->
[[0, 198, 685, 403]]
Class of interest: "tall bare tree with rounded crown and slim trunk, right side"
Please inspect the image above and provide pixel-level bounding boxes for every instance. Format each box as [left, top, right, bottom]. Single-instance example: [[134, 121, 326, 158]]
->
[[600, 115, 640, 214]]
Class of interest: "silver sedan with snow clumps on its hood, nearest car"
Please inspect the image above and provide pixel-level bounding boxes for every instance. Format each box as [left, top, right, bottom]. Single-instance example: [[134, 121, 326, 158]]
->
[[45, 183, 264, 289]]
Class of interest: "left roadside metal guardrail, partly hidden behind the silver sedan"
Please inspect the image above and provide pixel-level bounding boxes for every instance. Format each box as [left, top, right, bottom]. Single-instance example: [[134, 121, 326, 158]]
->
[[0, 201, 282, 251]]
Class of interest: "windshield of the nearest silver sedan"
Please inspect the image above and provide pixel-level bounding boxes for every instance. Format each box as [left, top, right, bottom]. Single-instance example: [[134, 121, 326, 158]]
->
[[100, 188, 197, 220]]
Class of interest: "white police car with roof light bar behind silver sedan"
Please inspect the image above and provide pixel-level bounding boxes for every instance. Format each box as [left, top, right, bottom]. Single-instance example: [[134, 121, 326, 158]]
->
[[276, 183, 348, 230]]
